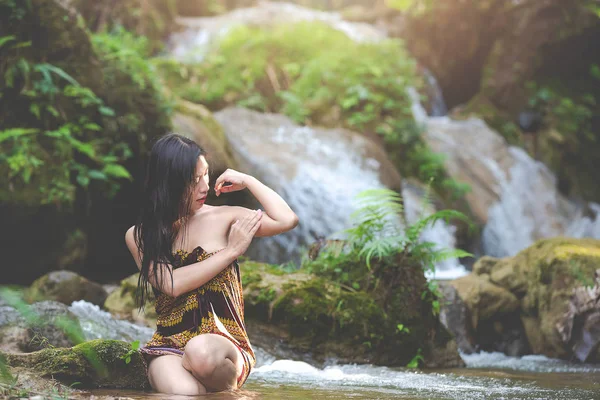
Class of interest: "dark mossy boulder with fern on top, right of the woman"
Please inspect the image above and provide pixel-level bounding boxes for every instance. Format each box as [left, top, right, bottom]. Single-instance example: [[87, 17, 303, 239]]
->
[[241, 189, 466, 367]]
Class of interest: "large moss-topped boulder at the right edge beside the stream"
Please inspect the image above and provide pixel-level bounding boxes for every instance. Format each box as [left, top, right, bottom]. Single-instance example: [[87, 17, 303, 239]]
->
[[452, 237, 600, 362]]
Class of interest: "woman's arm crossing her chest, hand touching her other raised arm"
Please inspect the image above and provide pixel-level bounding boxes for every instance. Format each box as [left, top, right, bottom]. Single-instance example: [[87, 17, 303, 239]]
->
[[125, 212, 261, 297]]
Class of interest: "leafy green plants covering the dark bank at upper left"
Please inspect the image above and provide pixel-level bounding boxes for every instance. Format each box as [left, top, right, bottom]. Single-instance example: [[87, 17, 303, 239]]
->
[[0, 1, 169, 207]]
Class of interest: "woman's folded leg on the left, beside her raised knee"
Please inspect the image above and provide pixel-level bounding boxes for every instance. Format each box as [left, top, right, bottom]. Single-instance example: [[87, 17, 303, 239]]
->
[[148, 354, 206, 396]]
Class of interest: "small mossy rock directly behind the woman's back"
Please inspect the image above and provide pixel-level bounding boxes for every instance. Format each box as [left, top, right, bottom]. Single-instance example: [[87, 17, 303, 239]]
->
[[104, 273, 157, 327]]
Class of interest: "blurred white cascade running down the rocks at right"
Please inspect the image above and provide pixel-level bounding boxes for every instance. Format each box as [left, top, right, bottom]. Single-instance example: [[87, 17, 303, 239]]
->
[[410, 86, 600, 257]]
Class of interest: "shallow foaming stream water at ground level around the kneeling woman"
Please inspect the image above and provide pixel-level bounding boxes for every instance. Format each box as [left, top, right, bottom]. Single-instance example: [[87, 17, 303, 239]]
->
[[70, 300, 600, 400]]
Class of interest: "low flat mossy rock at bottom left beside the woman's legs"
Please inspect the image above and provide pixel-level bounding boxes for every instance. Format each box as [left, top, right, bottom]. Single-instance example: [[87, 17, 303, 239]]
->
[[0, 339, 150, 389]]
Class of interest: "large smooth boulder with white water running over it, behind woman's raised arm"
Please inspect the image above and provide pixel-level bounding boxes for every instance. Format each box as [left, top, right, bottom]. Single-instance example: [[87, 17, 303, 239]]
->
[[215, 107, 402, 264]]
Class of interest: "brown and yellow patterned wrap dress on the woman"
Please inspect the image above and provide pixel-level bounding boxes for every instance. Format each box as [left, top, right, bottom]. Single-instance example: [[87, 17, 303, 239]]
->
[[140, 246, 256, 388]]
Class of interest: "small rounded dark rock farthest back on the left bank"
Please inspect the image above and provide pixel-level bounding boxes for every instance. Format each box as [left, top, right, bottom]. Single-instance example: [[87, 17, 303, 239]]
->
[[25, 271, 108, 306]]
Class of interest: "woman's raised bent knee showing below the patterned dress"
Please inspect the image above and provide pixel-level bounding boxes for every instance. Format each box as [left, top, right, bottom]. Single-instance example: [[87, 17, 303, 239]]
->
[[181, 333, 244, 392]]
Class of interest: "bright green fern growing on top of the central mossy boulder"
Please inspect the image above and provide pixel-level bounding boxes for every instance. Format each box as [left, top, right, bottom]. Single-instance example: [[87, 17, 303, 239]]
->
[[302, 188, 473, 315]]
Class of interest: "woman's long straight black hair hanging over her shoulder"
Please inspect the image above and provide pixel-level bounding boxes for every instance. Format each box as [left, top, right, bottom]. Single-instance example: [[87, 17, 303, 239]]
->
[[134, 133, 206, 310]]
